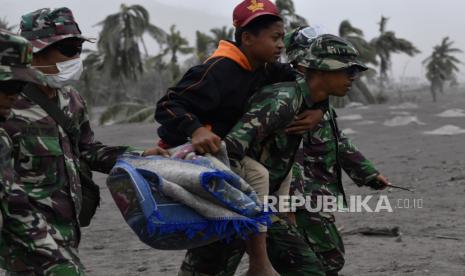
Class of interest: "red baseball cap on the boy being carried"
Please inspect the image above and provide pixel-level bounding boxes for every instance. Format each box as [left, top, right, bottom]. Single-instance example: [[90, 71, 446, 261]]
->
[[233, 0, 281, 28]]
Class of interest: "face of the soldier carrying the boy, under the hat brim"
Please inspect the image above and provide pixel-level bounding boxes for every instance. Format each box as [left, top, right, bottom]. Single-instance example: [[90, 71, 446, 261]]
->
[[321, 70, 355, 97]]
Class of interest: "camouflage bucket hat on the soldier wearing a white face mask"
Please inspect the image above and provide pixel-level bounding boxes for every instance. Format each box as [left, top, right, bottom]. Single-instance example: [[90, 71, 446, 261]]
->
[[21, 8, 93, 53]]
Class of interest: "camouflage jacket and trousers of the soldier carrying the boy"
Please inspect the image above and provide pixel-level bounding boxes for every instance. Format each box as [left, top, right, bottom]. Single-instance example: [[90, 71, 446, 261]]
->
[[179, 67, 324, 276]]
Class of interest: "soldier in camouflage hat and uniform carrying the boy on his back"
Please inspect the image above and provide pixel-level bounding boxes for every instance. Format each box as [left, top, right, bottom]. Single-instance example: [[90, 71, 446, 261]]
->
[[180, 35, 366, 275]]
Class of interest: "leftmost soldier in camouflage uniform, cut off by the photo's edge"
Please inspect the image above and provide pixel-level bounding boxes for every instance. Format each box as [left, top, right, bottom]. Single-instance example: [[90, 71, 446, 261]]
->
[[0, 30, 79, 275]]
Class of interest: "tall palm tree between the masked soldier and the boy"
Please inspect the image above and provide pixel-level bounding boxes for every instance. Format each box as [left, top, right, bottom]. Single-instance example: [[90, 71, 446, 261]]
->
[[93, 4, 166, 122]]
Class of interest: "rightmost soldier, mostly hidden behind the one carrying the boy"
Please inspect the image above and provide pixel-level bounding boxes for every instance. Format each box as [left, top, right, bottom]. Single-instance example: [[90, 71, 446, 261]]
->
[[286, 28, 388, 276]]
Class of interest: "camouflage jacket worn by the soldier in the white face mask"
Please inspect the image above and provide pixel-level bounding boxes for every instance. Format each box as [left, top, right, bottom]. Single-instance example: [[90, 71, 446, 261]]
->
[[2, 86, 133, 247]]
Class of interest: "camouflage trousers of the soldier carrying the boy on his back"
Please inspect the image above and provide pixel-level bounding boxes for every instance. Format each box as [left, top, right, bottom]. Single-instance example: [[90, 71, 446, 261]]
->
[[178, 219, 325, 276]]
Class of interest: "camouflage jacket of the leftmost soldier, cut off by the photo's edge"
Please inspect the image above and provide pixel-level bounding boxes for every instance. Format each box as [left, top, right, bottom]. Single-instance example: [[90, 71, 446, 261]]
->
[[0, 125, 78, 274]]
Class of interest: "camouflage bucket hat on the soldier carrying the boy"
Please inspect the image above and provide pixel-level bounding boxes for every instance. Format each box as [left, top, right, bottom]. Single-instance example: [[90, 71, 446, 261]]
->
[[285, 27, 368, 71]]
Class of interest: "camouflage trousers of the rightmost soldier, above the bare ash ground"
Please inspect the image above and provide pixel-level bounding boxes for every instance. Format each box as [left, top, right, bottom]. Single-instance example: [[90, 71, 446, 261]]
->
[[295, 210, 345, 275]]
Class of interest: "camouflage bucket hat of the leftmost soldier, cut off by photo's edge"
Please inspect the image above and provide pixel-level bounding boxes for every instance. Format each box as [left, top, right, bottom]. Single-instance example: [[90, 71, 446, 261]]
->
[[0, 30, 45, 85]]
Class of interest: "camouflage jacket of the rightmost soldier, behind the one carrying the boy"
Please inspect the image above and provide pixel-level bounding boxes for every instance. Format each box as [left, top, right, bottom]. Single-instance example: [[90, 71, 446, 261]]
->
[[291, 107, 379, 196]]
